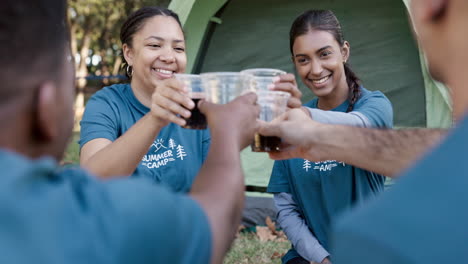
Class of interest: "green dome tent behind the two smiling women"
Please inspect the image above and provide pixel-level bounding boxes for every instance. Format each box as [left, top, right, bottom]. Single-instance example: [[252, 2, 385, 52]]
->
[[169, 0, 451, 198]]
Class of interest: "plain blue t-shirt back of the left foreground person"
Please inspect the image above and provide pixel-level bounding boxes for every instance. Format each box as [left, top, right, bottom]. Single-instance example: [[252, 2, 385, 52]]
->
[[0, 149, 212, 264]]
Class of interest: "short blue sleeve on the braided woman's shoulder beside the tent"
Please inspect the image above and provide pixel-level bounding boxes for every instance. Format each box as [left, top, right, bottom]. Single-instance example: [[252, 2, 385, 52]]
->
[[353, 91, 393, 128]]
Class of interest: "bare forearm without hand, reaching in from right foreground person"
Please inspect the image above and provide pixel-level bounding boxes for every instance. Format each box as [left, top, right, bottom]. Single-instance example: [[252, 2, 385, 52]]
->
[[309, 125, 447, 177]]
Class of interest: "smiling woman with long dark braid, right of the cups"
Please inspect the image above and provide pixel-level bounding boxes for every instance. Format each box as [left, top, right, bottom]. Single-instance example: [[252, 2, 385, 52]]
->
[[268, 10, 393, 264]]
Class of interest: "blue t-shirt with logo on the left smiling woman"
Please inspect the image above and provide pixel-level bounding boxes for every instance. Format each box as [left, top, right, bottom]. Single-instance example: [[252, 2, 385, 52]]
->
[[79, 84, 210, 192]]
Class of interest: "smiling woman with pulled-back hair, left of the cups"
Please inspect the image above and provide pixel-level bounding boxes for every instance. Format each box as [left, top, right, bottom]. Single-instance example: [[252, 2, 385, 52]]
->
[[79, 7, 301, 192]]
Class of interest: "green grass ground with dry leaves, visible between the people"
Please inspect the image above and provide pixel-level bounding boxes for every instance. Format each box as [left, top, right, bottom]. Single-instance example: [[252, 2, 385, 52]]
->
[[63, 133, 291, 264]]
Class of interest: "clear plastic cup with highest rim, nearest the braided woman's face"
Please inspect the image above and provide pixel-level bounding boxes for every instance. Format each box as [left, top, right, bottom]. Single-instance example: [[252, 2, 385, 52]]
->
[[241, 68, 286, 92]]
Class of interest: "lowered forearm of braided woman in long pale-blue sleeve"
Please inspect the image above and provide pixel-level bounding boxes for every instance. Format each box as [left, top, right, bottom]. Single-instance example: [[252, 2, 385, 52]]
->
[[274, 193, 330, 263]]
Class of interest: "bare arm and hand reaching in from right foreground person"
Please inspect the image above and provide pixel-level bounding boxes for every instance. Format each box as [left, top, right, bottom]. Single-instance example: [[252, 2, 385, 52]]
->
[[259, 109, 447, 177]]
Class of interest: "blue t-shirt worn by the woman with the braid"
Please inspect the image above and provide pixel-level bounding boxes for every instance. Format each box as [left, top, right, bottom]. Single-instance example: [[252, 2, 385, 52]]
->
[[268, 87, 393, 263]]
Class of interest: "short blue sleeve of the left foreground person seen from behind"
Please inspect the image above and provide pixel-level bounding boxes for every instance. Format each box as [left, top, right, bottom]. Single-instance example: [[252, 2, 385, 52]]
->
[[108, 179, 212, 264]]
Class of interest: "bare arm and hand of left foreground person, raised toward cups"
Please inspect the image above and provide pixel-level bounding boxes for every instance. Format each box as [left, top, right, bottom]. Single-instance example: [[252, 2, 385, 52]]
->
[[190, 94, 259, 263]]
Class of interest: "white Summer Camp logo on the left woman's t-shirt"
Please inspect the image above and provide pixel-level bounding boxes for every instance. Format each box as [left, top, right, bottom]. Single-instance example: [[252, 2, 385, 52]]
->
[[141, 138, 187, 169]]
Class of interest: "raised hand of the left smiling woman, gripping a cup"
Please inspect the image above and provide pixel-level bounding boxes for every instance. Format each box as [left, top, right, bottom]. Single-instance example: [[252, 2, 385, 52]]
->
[[151, 78, 195, 126]]
